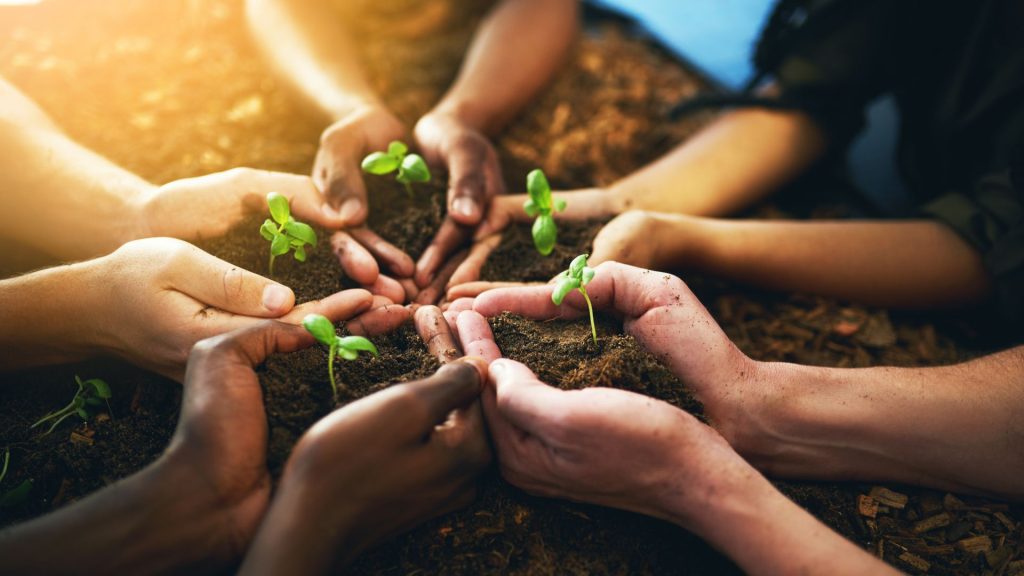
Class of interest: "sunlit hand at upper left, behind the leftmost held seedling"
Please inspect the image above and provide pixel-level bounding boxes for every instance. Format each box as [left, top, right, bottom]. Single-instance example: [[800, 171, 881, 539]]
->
[[137, 168, 344, 240]]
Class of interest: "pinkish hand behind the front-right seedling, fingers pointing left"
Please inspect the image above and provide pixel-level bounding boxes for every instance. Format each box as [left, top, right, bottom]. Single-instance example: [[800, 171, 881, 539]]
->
[[467, 262, 760, 439]]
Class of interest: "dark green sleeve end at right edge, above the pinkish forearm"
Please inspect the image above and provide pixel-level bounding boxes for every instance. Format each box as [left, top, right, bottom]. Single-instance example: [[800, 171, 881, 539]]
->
[[922, 170, 1024, 322]]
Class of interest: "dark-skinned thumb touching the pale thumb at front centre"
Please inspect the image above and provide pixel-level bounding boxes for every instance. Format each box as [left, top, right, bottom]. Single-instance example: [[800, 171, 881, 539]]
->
[[403, 359, 486, 429]]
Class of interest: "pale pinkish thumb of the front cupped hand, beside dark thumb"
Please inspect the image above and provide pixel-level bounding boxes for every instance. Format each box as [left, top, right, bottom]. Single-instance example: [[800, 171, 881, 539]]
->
[[488, 358, 565, 432]]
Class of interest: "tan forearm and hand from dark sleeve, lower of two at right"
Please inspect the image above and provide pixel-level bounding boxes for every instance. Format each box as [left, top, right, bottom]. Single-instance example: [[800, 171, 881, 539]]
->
[[593, 212, 991, 310]]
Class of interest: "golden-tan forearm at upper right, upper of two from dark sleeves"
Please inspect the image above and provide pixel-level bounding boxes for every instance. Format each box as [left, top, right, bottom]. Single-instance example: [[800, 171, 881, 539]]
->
[[611, 105, 825, 216]]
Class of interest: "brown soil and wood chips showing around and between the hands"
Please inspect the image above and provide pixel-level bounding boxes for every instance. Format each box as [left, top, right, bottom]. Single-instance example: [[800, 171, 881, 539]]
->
[[0, 0, 1024, 574]]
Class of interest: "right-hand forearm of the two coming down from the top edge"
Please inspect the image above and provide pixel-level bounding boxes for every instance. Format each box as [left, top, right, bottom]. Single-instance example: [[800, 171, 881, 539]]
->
[[434, 0, 579, 135]]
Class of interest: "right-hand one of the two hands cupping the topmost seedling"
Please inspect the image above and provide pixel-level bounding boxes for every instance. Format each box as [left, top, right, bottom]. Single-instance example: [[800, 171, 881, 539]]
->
[[407, 113, 505, 288]]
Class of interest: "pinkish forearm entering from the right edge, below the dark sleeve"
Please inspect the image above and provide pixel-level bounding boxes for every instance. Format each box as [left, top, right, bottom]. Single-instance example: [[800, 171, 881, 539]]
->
[[730, 347, 1024, 500]]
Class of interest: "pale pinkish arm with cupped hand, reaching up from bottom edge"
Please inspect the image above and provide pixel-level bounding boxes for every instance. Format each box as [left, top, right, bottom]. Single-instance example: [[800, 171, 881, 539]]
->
[[457, 311, 895, 574]]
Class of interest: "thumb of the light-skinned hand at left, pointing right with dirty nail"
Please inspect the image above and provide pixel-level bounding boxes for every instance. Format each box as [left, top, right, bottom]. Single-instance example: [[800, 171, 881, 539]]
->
[[163, 242, 295, 318]]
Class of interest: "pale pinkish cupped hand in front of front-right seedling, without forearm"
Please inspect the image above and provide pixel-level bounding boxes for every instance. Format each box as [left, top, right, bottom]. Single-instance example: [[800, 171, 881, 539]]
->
[[458, 311, 756, 526]]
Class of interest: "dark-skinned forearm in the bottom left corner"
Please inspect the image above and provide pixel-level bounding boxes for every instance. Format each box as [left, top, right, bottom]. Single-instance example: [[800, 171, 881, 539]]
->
[[0, 456, 238, 575]]
